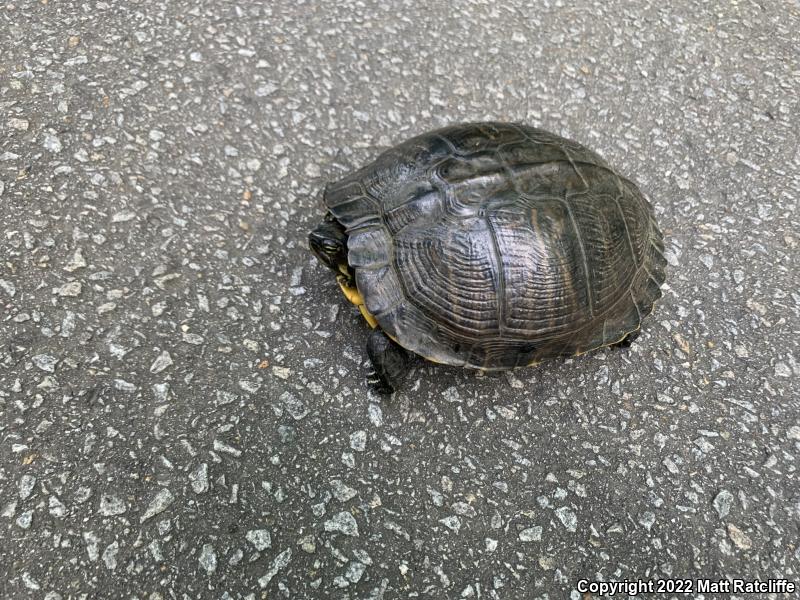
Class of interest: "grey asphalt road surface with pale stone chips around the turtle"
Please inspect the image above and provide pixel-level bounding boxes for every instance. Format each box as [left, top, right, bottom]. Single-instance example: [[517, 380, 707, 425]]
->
[[0, 0, 800, 600]]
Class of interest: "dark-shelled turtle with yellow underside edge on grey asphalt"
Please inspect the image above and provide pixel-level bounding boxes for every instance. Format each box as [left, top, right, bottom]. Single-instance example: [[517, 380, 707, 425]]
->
[[309, 122, 666, 393]]
